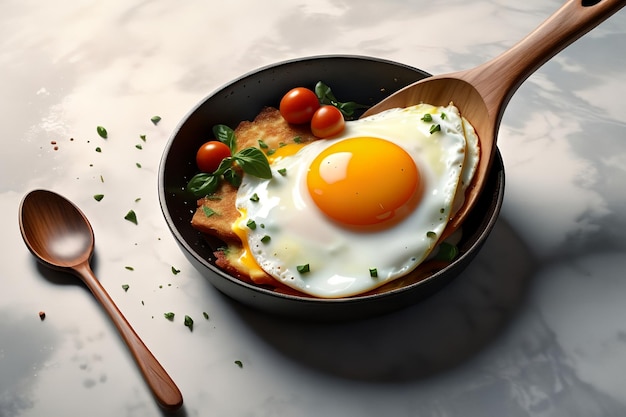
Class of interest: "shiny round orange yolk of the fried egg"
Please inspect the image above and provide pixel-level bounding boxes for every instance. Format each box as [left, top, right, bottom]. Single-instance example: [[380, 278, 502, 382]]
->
[[307, 137, 422, 226]]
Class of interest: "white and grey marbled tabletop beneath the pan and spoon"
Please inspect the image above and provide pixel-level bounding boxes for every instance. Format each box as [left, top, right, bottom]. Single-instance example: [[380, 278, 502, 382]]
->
[[0, 0, 626, 417]]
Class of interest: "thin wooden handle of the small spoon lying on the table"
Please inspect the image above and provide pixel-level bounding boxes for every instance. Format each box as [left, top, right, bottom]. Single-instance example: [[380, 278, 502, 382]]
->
[[72, 262, 183, 411]]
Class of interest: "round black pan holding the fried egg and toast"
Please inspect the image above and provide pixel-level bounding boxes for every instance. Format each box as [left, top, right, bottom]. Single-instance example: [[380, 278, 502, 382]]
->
[[158, 55, 504, 321]]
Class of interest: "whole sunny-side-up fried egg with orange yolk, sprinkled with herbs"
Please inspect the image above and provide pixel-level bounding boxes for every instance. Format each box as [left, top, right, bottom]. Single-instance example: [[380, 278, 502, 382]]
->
[[233, 104, 479, 298]]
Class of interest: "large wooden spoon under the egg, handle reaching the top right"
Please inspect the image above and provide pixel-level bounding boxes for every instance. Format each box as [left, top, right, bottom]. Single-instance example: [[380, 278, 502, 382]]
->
[[362, 0, 626, 236]]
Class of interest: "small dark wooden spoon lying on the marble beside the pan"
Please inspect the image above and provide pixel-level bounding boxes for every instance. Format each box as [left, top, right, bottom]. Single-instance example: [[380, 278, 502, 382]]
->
[[19, 190, 183, 411]]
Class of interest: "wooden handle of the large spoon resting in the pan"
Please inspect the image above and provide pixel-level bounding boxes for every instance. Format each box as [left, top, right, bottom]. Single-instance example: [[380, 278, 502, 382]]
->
[[464, 0, 626, 112]]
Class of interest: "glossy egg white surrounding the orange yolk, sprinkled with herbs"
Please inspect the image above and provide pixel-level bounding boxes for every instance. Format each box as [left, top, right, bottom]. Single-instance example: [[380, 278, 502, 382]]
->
[[234, 104, 479, 298]]
